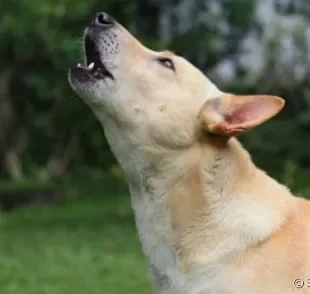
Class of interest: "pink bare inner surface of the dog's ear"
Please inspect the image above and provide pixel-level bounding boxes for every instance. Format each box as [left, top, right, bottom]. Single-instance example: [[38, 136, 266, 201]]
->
[[225, 99, 270, 125]]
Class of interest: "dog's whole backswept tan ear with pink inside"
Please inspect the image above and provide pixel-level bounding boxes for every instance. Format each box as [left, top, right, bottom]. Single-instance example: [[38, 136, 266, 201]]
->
[[199, 94, 285, 137]]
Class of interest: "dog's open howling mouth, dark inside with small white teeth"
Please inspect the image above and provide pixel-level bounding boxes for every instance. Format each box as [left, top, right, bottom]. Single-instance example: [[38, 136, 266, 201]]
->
[[77, 35, 114, 79]]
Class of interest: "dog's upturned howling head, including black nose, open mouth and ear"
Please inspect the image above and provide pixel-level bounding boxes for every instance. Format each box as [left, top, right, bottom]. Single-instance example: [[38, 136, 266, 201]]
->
[[69, 13, 284, 148]]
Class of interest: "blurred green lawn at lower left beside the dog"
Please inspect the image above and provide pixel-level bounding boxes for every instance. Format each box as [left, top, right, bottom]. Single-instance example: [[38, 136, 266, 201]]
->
[[0, 197, 150, 294]]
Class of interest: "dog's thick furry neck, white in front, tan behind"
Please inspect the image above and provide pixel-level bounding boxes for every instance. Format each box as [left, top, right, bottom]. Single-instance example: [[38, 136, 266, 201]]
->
[[102, 118, 293, 274]]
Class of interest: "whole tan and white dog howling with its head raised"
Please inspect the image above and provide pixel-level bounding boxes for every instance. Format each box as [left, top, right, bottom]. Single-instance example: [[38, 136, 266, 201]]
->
[[69, 13, 310, 294]]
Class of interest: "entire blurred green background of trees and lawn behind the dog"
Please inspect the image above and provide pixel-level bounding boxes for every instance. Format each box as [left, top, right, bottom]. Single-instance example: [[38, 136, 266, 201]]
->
[[0, 0, 310, 294]]
